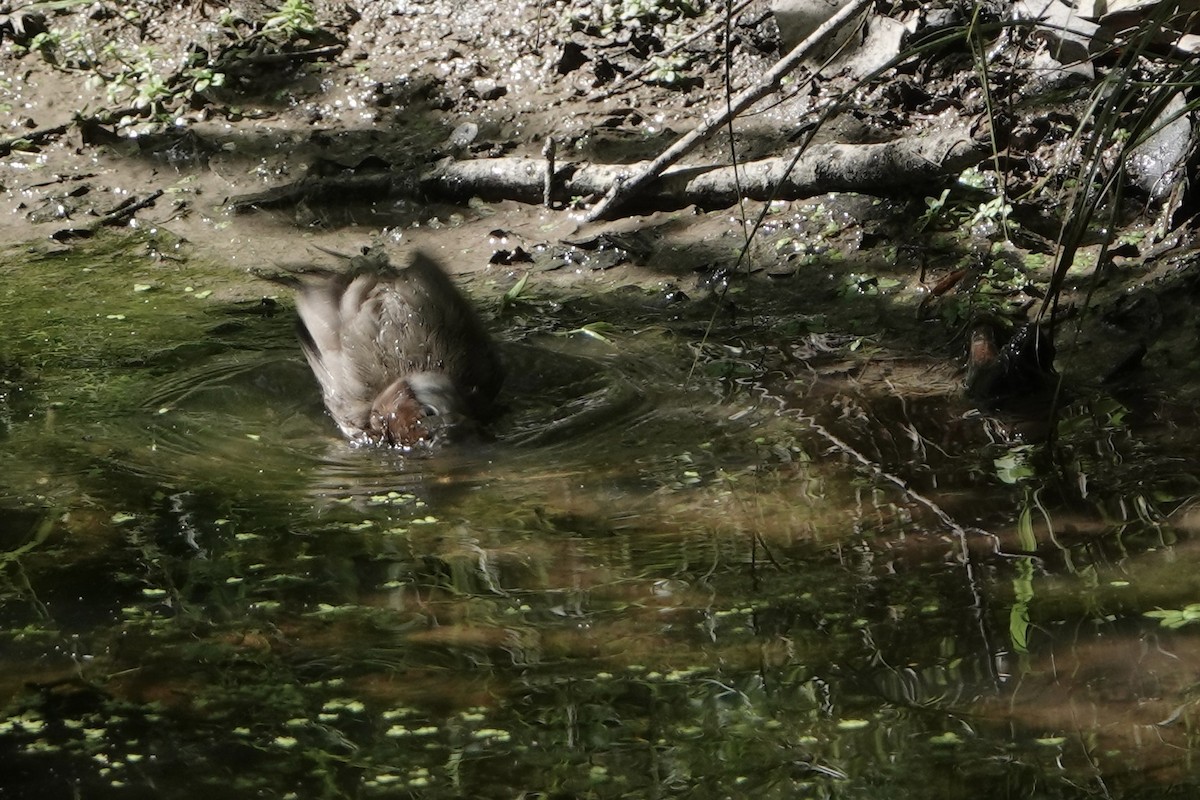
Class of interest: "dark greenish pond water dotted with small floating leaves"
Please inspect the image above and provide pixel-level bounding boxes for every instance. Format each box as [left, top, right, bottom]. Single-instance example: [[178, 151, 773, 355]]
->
[[0, 235, 1200, 799]]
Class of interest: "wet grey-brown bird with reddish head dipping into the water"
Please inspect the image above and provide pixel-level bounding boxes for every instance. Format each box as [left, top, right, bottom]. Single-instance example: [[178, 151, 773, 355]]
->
[[288, 247, 504, 451]]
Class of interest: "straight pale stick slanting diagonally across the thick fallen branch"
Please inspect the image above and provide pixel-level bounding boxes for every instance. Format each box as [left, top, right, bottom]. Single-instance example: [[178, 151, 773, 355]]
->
[[586, 0, 871, 222]]
